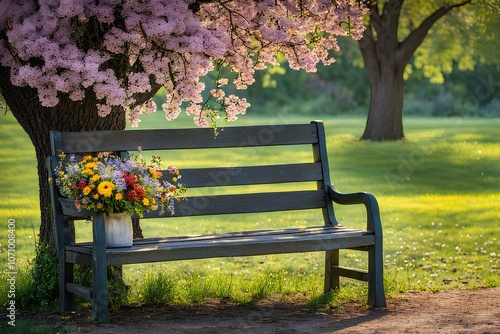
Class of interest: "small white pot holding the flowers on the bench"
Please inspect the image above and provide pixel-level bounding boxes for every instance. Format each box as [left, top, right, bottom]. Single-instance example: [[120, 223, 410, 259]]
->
[[104, 212, 133, 248]]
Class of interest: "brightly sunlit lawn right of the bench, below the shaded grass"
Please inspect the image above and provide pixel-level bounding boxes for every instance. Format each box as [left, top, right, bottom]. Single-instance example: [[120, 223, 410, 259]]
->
[[381, 194, 500, 290]]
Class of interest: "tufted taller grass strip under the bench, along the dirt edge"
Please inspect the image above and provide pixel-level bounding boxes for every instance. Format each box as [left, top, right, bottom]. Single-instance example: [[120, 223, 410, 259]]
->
[[128, 264, 322, 305]]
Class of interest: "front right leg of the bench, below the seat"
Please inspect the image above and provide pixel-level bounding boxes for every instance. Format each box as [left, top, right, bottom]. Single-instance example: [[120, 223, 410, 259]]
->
[[368, 243, 386, 307]]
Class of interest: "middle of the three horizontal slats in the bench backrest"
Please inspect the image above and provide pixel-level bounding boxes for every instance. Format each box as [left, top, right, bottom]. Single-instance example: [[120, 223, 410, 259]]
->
[[170, 162, 323, 189]]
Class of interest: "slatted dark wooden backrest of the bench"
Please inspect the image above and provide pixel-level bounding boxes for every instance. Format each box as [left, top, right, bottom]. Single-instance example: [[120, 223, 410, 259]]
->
[[47, 121, 337, 224]]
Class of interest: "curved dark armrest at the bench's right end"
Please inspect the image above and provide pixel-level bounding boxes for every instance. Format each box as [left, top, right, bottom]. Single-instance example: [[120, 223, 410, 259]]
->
[[328, 185, 382, 236]]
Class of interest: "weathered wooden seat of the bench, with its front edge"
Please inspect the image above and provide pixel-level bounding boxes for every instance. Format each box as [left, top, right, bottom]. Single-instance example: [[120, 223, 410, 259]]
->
[[66, 225, 374, 265]]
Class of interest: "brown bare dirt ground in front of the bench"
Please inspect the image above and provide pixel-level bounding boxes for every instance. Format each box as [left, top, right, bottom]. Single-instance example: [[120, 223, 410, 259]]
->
[[20, 288, 500, 334]]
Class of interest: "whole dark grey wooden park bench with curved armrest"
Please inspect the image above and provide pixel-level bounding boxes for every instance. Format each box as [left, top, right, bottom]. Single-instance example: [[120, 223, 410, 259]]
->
[[48, 121, 386, 323]]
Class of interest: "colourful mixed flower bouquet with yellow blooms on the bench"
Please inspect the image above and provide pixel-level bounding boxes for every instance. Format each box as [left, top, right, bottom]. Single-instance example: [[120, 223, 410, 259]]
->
[[54, 148, 186, 217]]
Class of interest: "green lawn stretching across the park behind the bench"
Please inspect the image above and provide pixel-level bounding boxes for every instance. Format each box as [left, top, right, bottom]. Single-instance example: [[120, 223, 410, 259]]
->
[[0, 113, 500, 302]]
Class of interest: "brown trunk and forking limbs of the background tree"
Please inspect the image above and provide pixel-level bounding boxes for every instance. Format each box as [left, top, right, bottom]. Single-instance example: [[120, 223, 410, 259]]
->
[[359, 0, 471, 141]]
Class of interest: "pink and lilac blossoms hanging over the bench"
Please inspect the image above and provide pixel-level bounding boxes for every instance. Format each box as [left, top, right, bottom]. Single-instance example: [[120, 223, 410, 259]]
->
[[0, 0, 364, 125]]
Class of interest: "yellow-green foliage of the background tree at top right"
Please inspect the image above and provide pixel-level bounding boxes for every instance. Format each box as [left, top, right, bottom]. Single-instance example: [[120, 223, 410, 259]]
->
[[400, 0, 500, 83]]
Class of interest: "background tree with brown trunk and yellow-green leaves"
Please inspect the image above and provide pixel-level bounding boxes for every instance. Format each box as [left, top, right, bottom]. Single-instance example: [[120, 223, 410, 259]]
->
[[359, 0, 499, 140]]
